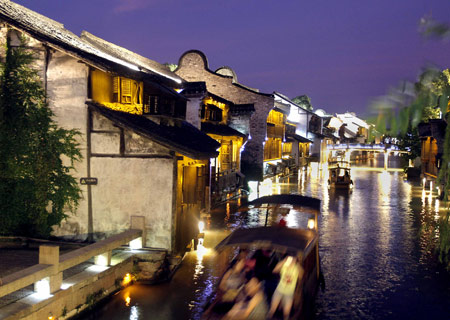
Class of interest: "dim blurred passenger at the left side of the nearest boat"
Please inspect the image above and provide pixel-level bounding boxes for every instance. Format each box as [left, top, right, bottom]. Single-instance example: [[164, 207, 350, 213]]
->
[[219, 259, 245, 303]]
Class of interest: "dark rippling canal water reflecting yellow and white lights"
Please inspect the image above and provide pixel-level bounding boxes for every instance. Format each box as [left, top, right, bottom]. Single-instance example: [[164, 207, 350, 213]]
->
[[83, 161, 450, 320]]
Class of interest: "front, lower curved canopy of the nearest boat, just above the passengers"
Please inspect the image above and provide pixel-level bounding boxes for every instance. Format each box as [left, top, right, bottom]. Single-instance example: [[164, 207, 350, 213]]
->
[[215, 226, 318, 252]]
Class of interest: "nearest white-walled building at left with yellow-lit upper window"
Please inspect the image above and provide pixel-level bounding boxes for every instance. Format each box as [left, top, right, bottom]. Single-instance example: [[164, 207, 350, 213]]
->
[[0, 1, 220, 251]]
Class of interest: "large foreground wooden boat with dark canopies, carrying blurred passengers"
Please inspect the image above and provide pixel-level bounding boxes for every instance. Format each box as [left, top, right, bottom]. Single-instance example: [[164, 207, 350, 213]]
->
[[202, 195, 323, 319]]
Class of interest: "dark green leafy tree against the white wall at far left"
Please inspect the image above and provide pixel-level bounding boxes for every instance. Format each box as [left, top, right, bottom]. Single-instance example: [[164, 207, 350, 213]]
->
[[0, 34, 81, 237]]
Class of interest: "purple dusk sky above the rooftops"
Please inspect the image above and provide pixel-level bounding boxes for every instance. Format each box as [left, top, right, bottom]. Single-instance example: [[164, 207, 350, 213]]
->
[[15, 0, 450, 115]]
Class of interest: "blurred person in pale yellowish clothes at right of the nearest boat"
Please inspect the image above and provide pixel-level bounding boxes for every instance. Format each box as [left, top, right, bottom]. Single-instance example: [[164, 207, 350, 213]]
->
[[269, 256, 304, 319]]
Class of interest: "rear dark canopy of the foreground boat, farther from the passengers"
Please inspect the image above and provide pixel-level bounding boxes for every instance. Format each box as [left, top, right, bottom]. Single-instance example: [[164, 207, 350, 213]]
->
[[246, 194, 320, 213]]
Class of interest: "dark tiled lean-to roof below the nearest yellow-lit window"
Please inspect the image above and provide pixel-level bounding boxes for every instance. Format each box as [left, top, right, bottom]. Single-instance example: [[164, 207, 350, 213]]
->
[[88, 102, 220, 159]]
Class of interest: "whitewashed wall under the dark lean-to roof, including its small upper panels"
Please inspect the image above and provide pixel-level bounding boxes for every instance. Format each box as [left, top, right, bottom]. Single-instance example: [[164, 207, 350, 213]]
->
[[91, 112, 175, 250]]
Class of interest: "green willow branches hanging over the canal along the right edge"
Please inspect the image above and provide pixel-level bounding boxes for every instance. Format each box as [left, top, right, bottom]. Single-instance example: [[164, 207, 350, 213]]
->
[[373, 68, 450, 268]]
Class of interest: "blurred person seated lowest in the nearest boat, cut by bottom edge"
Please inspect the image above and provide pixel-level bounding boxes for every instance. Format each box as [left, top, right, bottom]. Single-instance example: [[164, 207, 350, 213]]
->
[[224, 277, 269, 320]]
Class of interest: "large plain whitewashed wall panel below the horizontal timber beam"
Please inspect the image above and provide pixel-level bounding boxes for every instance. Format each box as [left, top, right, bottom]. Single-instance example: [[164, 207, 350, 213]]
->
[[91, 157, 173, 249]]
